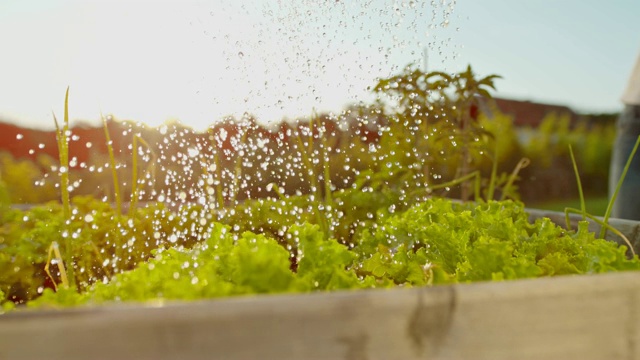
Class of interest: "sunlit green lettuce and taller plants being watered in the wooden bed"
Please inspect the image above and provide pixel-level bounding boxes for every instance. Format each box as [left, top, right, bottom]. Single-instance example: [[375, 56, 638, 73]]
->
[[0, 66, 640, 311]]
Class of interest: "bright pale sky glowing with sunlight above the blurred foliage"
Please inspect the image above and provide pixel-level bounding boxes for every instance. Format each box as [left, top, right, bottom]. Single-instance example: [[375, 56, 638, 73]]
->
[[0, 0, 640, 129]]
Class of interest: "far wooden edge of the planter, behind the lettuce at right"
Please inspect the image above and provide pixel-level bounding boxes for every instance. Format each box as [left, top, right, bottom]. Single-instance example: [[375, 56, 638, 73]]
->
[[525, 208, 640, 254]]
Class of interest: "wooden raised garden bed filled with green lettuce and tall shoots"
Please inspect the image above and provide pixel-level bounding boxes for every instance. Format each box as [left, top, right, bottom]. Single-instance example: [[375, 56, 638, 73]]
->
[[0, 67, 640, 359]]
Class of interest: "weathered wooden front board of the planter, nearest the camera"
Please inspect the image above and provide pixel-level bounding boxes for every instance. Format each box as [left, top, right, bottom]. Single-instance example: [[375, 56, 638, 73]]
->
[[0, 272, 640, 360]]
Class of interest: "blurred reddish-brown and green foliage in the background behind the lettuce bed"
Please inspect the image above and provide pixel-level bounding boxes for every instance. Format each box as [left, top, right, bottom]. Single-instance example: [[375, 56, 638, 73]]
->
[[0, 66, 616, 210]]
